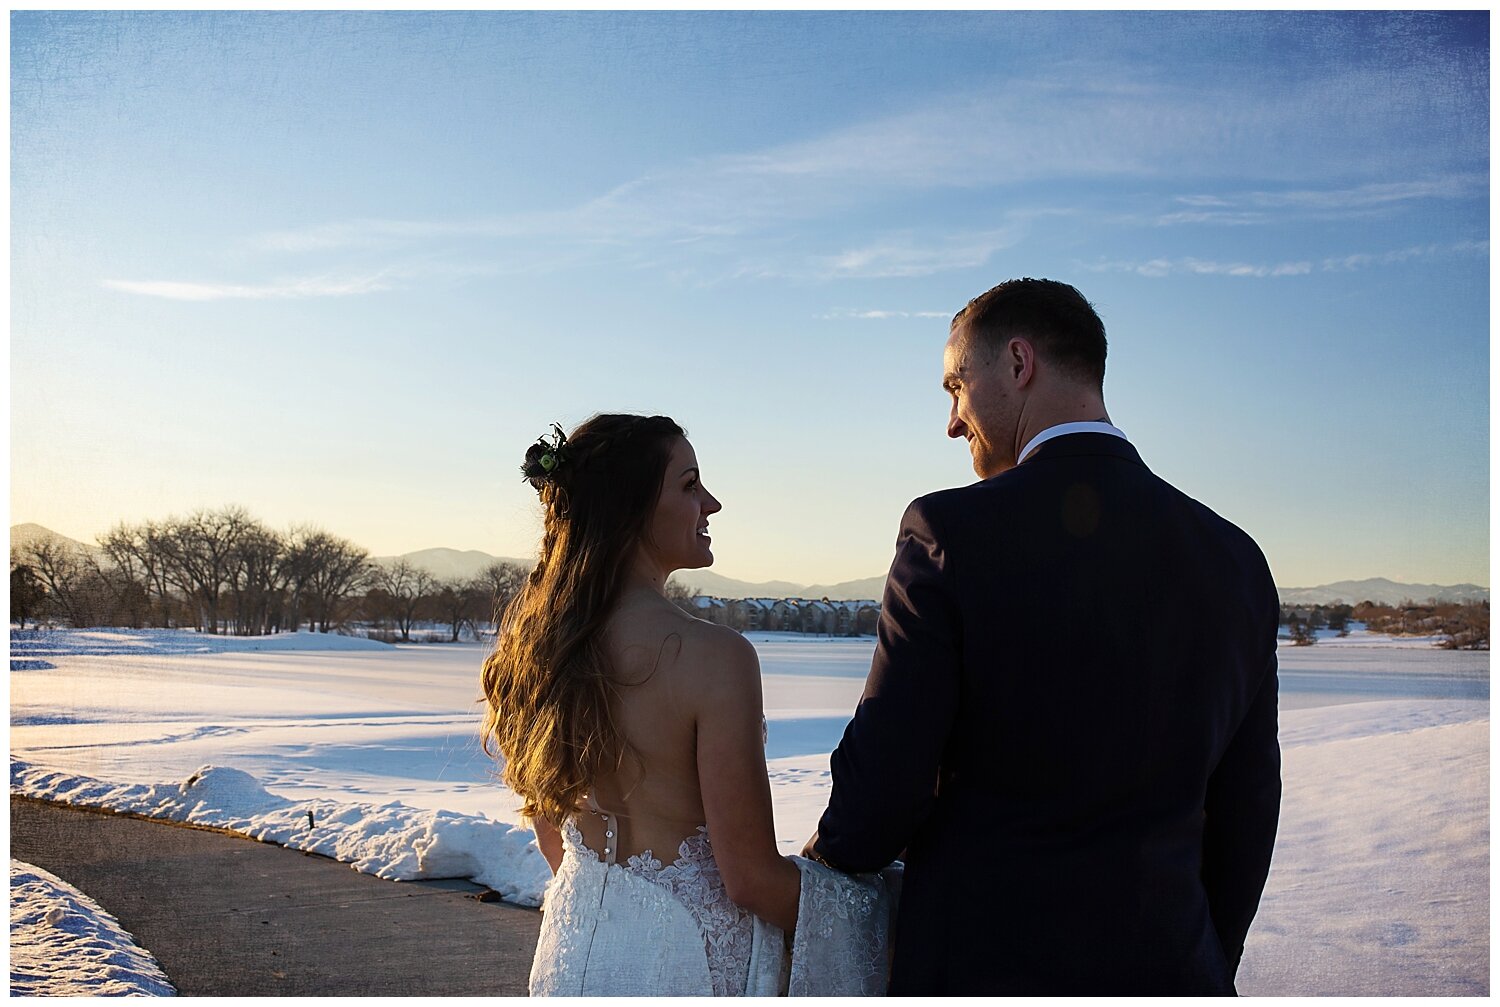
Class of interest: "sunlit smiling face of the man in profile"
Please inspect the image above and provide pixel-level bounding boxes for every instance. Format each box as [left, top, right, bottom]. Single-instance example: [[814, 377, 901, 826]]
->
[[942, 327, 1017, 479]]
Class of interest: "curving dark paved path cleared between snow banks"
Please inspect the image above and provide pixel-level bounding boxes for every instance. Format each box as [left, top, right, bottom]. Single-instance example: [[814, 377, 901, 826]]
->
[[11, 797, 542, 996]]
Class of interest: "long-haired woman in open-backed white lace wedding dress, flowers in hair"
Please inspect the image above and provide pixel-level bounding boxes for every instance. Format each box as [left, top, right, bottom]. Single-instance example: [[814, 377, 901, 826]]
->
[[483, 414, 822, 995]]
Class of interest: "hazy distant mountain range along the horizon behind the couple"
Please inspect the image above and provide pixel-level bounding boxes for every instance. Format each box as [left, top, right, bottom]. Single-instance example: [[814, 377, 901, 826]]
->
[[11, 524, 1490, 605]]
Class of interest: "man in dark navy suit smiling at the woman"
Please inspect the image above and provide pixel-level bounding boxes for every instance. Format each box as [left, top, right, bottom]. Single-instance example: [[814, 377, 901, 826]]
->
[[806, 279, 1281, 995]]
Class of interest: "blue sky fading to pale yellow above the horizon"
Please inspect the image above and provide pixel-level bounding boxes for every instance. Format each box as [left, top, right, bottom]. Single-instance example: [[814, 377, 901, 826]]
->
[[11, 12, 1490, 587]]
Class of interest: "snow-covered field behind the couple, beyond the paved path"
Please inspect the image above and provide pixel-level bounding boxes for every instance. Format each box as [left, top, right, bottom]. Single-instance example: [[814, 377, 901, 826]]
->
[[11, 630, 1490, 995]]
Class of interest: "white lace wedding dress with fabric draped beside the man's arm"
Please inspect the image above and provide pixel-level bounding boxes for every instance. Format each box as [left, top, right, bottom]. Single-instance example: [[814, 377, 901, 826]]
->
[[531, 819, 900, 996]]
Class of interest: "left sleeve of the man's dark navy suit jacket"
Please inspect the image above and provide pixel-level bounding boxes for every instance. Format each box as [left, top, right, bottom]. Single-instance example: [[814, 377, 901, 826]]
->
[[816, 500, 962, 872]]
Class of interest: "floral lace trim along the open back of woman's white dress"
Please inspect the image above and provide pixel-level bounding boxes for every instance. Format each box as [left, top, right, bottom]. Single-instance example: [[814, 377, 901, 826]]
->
[[563, 821, 755, 996]]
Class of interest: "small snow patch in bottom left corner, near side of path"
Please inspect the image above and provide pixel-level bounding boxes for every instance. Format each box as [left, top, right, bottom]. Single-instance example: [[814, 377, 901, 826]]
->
[[11, 860, 177, 996]]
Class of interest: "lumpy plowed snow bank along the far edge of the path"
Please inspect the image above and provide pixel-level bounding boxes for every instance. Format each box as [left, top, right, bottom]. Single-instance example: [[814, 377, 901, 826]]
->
[[11, 758, 552, 906]]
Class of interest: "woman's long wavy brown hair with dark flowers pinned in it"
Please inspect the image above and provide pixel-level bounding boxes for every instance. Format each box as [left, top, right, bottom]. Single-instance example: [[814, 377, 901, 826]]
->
[[482, 414, 683, 825]]
